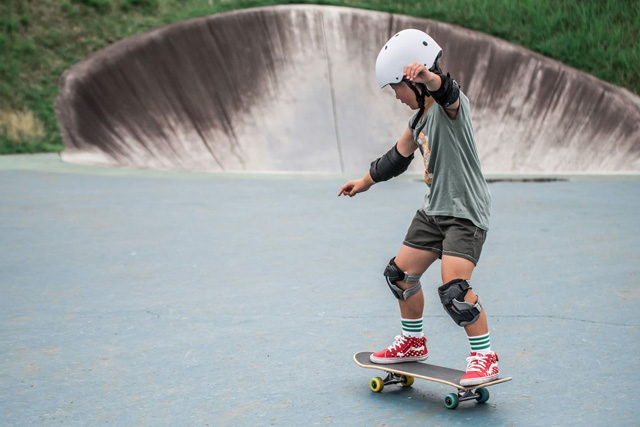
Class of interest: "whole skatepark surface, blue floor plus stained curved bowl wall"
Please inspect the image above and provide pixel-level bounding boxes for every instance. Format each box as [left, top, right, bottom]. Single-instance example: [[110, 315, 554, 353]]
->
[[0, 6, 640, 427]]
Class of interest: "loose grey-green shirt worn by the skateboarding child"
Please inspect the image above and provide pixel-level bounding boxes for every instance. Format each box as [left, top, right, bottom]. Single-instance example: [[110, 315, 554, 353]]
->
[[409, 92, 491, 230]]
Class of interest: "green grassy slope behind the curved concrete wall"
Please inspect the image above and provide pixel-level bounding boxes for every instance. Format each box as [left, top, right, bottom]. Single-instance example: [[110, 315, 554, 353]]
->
[[0, 0, 640, 154]]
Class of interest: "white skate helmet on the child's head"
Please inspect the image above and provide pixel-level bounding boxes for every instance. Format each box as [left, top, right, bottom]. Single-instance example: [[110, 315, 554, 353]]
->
[[376, 30, 442, 88]]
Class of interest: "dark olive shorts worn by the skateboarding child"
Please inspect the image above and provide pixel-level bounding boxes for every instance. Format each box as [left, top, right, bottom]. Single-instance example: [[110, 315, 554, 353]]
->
[[403, 209, 487, 265]]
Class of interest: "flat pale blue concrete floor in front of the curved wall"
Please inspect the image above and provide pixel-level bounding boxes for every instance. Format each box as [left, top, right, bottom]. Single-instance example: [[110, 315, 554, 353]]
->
[[0, 155, 640, 426]]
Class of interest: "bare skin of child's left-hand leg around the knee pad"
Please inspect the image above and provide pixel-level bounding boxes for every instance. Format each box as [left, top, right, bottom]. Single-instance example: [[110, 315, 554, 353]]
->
[[395, 245, 439, 319]]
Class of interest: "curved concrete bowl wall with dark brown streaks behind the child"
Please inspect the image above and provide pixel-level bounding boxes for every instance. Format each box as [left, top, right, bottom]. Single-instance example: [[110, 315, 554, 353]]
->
[[56, 6, 640, 174]]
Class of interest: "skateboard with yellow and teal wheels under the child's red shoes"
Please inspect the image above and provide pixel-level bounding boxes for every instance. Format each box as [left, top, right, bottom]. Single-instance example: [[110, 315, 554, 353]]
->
[[353, 351, 512, 409]]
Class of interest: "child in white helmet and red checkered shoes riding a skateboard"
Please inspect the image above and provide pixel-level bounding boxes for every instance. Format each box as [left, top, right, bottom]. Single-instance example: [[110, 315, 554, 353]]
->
[[338, 30, 498, 386]]
